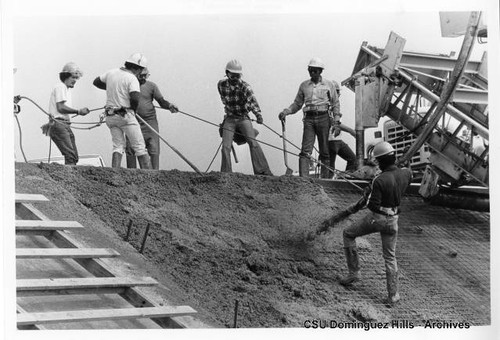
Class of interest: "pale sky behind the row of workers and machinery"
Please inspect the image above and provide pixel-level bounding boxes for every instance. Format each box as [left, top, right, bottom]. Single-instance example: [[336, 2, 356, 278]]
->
[[5, 2, 494, 175]]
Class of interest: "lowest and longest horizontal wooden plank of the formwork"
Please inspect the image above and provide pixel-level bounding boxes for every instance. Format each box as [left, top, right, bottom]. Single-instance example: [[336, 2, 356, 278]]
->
[[17, 306, 196, 326]]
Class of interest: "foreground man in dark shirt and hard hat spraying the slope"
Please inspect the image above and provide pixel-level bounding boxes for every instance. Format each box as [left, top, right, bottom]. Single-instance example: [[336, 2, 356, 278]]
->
[[340, 142, 412, 305]]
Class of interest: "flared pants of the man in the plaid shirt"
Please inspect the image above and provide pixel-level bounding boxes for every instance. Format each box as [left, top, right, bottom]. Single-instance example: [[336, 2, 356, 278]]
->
[[220, 116, 272, 176]]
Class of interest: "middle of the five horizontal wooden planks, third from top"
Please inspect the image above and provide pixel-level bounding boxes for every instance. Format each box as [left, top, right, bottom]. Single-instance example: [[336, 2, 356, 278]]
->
[[16, 248, 120, 259]]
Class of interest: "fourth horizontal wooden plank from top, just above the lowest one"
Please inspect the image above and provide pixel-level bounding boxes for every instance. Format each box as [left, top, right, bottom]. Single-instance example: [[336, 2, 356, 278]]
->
[[16, 277, 158, 297]]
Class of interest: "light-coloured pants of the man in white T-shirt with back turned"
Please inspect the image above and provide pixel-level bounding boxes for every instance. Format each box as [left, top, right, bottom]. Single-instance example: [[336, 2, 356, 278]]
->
[[106, 111, 148, 156]]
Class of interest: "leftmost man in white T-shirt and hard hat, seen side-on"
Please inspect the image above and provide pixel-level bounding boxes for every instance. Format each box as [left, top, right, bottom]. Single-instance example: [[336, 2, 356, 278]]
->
[[42, 62, 90, 165]]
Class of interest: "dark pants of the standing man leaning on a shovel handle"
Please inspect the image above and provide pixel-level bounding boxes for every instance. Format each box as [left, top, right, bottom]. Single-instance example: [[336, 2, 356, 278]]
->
[[299, 114, 330, 178]]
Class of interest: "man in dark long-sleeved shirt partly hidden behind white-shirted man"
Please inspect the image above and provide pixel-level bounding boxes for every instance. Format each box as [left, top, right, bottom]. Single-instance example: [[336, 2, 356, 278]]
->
[[125, 67, 179, 170]]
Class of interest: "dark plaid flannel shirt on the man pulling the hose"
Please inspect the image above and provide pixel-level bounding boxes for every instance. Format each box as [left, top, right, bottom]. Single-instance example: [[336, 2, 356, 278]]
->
[[217, 79, 261, 117]]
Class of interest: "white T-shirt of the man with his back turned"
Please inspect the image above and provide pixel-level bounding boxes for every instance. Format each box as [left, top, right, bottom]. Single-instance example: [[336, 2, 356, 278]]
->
[[99, 68, 141, 108]]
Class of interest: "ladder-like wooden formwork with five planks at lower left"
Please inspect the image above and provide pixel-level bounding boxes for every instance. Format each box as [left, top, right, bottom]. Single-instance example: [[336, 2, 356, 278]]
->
[[15, 194, 196, 329]]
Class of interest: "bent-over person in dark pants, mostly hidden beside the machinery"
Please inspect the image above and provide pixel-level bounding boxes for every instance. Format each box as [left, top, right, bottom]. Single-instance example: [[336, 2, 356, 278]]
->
[[328, 124, 356, 178]]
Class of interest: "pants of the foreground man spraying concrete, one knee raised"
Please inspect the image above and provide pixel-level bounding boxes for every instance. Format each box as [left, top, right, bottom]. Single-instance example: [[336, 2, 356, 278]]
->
[[343, 211, 398, 272]]
